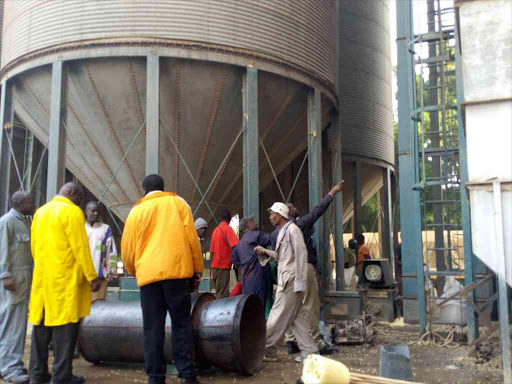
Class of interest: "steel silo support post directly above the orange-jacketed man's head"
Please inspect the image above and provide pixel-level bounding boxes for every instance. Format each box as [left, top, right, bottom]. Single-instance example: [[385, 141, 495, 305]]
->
[[146, 56, 160, 175]]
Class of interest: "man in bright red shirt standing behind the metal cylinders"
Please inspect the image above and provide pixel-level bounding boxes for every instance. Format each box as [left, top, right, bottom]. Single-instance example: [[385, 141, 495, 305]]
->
[[210, 209, 238, 299]]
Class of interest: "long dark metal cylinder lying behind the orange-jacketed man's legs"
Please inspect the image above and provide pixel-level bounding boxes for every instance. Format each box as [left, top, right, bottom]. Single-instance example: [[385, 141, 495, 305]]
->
[[78, 292, 215, 363]]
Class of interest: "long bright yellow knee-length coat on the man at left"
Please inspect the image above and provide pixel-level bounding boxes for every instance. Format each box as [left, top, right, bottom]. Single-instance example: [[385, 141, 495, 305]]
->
[[29, 196, 98, 326]]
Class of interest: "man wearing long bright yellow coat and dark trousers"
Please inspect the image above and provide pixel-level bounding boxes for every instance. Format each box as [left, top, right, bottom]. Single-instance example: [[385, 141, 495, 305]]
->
[[29, 183, 99, 384]]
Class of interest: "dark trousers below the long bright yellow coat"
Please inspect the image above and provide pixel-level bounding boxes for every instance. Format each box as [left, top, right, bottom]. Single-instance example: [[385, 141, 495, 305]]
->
[[30, 318, 79, 384]]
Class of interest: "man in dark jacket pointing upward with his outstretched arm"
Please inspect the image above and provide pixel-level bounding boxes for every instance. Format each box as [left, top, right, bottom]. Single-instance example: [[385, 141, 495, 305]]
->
[[278, 181, 343, 355]]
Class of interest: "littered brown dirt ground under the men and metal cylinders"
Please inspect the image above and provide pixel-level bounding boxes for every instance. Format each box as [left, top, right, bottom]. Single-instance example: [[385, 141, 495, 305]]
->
[[0, 323, 503, 384]]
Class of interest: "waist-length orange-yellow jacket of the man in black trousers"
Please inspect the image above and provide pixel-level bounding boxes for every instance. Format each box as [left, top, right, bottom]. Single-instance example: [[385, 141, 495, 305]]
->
[[121, 192, 203, 286]]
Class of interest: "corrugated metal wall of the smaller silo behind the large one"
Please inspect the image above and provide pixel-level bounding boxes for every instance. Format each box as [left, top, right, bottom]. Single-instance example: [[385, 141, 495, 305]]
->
[[338, 0, 394, 164]]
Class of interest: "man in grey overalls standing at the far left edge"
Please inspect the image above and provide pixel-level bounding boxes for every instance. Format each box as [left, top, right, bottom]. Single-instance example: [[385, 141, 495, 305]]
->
[[0, 192, 35, 383]]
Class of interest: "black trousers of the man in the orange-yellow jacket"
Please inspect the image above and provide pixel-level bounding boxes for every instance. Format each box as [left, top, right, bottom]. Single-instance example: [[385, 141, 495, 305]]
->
[[140, 279, 196, 384]]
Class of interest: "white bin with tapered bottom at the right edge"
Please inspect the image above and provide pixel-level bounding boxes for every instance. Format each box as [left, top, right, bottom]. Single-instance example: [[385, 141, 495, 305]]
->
[[458, 0, 512, 286]]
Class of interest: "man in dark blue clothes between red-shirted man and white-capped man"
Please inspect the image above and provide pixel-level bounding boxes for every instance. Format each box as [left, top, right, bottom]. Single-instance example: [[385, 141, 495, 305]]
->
[[231, 215, 272, 305]]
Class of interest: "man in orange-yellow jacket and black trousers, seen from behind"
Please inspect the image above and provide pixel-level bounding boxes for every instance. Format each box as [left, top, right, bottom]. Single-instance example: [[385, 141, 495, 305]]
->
[[121, 175, 203, 384]]
